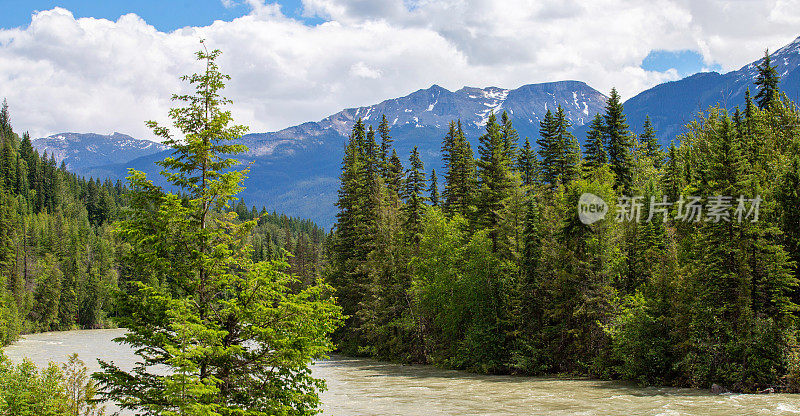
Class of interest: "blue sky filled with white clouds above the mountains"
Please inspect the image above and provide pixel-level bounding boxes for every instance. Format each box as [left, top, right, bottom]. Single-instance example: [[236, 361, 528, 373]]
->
[[0, 0, 800, 140]]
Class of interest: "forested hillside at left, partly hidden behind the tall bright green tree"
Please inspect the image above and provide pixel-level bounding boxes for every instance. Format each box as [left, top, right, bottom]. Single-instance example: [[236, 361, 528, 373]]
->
[[0, 99, 326, 345]]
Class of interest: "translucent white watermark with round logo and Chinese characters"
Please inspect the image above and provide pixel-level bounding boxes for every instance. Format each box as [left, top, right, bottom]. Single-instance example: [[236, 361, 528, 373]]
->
[[578, 193, 762, 225]]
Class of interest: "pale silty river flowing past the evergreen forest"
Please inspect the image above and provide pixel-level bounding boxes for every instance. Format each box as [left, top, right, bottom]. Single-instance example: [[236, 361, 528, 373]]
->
[[5, 329, 800, 416]]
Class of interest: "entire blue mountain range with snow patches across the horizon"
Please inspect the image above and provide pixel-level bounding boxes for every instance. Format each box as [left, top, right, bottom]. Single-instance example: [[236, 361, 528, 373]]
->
[[33, 38, 800, 227]]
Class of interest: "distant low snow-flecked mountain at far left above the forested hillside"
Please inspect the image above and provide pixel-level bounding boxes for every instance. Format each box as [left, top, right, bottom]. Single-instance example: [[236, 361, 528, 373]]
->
[[31, 133, 167, 172]]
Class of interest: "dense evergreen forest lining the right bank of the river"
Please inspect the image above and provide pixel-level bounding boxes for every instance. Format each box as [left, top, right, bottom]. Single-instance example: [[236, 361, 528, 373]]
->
[[327, 62, 800, 391]]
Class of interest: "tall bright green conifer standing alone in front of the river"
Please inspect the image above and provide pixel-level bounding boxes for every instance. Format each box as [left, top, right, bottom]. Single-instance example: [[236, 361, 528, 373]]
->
[[94, 43, 339, 416]]
